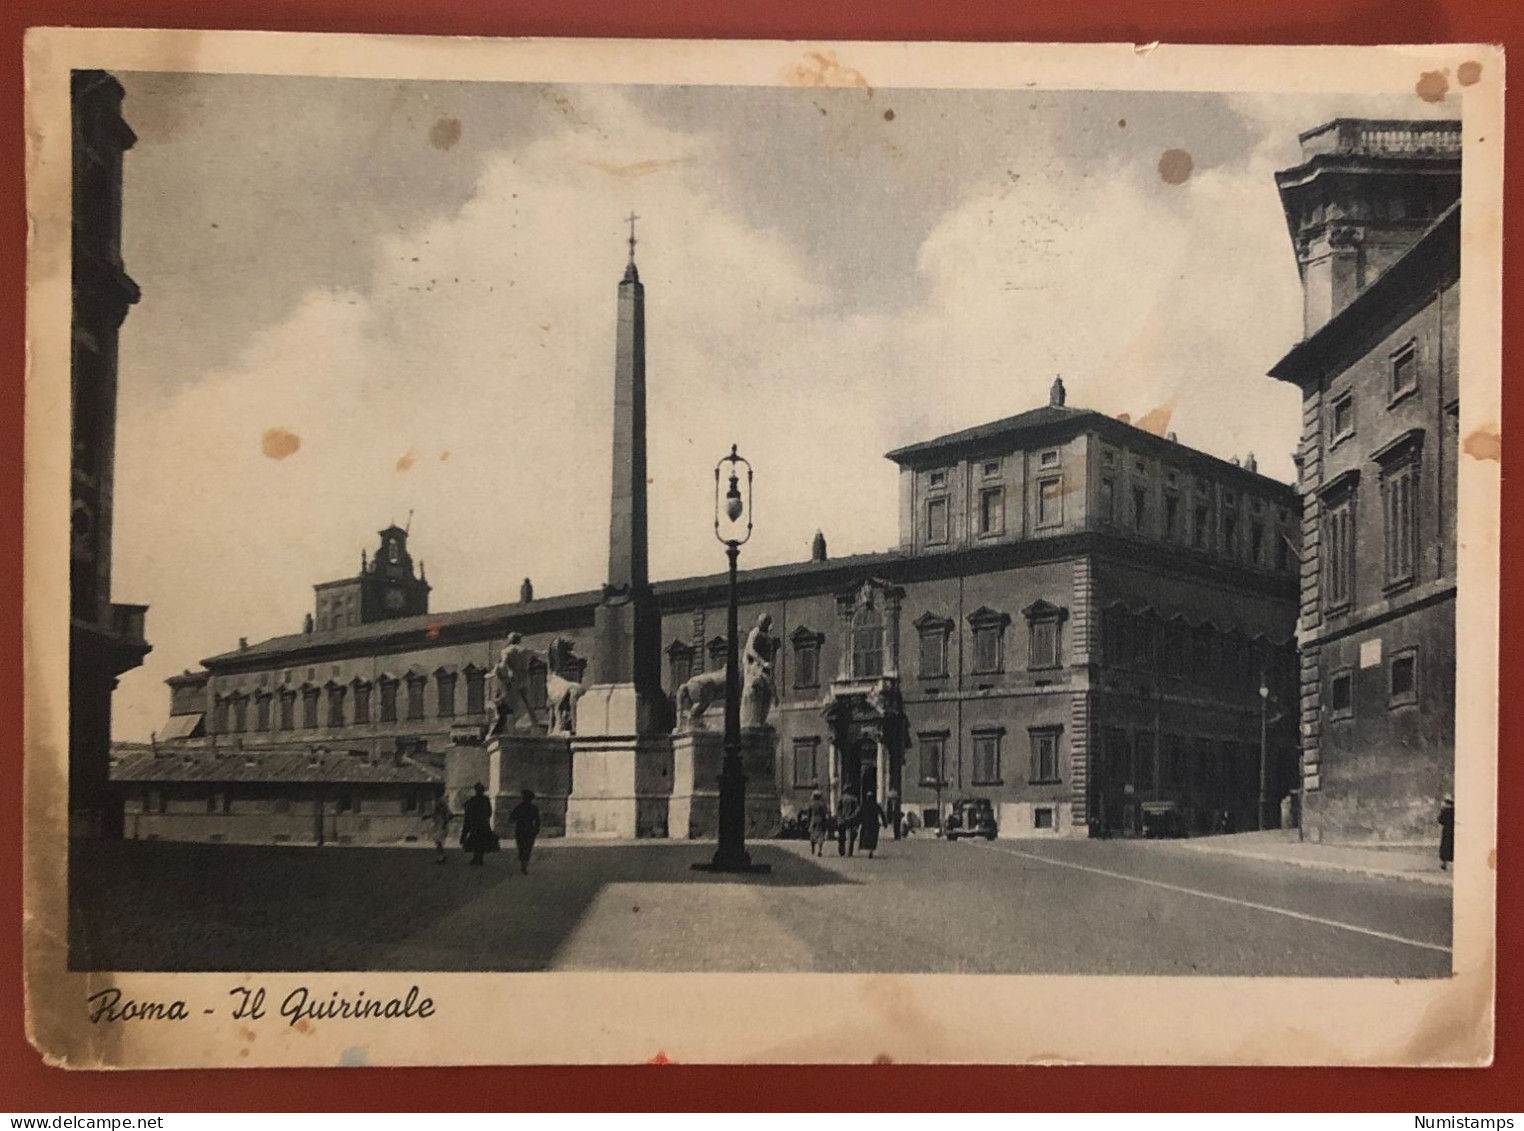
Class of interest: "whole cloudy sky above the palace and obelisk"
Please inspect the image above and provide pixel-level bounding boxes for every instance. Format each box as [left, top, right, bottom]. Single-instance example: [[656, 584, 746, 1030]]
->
[[104, 73, 1455, 739]]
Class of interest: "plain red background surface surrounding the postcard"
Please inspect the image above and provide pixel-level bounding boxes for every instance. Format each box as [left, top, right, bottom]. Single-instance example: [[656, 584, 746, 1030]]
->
[[0, 0, 1524, 1113]]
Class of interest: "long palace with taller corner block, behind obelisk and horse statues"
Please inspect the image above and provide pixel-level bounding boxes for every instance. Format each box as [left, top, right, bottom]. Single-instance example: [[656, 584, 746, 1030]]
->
[[137, 381, 1301, 840]]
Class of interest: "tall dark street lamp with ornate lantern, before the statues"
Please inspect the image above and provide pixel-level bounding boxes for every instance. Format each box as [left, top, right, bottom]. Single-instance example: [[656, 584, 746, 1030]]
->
[[693, 444, 773, 872]]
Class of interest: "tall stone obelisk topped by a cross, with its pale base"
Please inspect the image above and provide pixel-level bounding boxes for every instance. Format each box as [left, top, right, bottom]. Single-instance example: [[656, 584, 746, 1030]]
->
[[567, 215, 672, 837]]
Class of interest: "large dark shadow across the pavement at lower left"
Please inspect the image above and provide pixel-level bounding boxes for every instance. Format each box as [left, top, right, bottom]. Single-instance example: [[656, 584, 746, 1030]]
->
[[69, 841, 853, 971]]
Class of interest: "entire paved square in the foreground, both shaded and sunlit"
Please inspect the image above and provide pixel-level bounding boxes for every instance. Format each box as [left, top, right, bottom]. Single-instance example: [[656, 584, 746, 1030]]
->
[[70, 837, 1451, 977]]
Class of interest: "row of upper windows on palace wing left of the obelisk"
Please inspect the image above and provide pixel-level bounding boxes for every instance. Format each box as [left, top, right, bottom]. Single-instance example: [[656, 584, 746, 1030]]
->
[[212, 665, 502, 735]]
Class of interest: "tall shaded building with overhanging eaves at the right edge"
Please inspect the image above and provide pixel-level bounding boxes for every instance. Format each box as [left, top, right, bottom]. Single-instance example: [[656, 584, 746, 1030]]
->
[[1269, 119, 1462, 841]]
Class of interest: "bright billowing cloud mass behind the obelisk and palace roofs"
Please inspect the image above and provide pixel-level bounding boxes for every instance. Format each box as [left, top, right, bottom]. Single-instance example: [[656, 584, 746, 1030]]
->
[[114, 87, 1408, 736]]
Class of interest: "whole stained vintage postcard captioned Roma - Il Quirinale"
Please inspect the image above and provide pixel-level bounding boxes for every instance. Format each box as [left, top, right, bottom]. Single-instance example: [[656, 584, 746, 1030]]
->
[[24, 29, 1504, 1069]]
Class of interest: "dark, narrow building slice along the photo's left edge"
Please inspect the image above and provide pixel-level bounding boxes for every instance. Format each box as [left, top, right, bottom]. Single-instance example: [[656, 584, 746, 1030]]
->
[[69, 70, 149, 835]]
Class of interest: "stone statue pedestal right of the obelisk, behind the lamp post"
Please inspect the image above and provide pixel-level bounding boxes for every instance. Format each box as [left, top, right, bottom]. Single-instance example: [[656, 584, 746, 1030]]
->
[[668, 727, 783, 840]]
